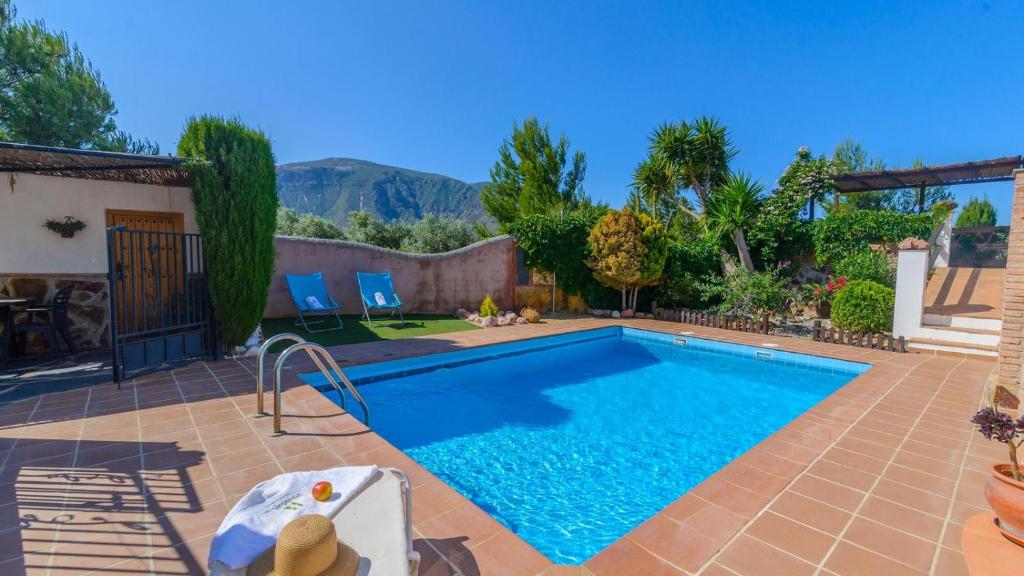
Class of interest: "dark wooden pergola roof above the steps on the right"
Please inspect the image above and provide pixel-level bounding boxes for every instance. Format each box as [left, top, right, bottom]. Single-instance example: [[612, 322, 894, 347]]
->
[[831, 156, 1024, 214]]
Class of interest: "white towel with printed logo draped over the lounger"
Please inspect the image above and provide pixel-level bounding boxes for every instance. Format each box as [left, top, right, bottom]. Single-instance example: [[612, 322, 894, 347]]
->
[[207, 466, 377, 570]]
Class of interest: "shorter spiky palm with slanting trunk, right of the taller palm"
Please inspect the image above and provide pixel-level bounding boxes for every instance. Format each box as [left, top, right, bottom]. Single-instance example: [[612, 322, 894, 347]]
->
[[705, 173, 765, 272]]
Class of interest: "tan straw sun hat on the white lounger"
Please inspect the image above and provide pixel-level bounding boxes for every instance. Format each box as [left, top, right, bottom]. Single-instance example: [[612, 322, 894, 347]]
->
[[246, 515, 359, 576]]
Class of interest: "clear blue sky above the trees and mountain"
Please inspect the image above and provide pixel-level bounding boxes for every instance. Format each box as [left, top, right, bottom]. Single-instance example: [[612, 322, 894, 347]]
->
[[16, 0, 1024, 222]]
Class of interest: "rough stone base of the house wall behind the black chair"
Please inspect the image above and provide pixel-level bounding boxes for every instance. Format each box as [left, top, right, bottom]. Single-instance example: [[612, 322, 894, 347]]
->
[[0, 274, 111, 352]]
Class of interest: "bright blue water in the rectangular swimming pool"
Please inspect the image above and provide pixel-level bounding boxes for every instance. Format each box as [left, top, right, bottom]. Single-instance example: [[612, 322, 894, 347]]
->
[[304, 327, 868, 564]]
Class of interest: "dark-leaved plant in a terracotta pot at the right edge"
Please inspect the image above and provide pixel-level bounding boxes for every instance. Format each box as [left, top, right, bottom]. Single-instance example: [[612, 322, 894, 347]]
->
[[971, 386, 1024, 545]]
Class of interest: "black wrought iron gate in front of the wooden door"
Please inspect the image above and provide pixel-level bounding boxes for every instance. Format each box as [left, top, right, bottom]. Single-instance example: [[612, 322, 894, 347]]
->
[[106, 225, 220, 382]]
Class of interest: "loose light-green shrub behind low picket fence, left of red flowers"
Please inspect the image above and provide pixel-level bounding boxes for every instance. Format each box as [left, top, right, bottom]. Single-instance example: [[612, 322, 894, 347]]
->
[[696, 266, 793, 316]]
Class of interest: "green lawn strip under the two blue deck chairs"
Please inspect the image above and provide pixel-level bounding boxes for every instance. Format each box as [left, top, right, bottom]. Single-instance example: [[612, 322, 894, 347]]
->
[[262, 314, 479, 352]]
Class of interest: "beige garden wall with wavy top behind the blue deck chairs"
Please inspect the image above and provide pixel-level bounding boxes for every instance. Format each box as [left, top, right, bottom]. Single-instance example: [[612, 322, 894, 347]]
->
[[264, 236, 515, 318]]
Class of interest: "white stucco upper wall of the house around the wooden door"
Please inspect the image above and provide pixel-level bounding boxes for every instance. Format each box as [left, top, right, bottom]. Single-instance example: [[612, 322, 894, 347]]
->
[[0, 173, 199, 275]]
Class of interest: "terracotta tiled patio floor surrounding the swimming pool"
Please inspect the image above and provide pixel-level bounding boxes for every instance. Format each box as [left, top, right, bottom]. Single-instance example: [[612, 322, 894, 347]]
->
[[0, 319, 1005, 576]]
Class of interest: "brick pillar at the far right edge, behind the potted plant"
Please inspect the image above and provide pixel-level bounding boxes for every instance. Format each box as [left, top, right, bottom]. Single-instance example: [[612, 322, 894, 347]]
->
[[998, 170, 1024, 390]]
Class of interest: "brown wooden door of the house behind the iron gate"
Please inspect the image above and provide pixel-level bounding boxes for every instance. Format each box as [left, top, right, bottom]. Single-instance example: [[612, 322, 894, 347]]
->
[[106, 210, 187, 332]]
